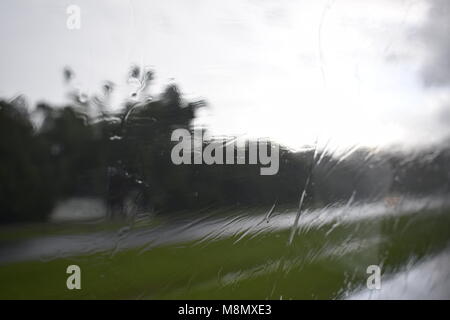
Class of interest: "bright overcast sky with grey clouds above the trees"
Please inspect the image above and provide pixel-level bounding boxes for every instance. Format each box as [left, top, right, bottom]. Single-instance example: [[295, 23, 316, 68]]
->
[[0, 0, 450, 148]]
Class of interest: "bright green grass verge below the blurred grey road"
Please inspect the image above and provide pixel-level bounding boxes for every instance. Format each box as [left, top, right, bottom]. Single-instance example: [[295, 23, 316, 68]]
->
[[0, 206, 450, 299]]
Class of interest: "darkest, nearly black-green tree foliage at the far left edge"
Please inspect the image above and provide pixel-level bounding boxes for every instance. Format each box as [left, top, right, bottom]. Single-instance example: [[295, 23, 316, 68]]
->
[[0, 101, 56, 223]]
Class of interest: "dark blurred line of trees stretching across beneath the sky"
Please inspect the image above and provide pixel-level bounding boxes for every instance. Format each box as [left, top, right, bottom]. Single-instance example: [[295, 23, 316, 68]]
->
[[0, 67, 450, 224]]
